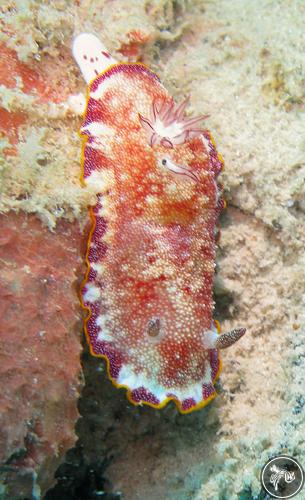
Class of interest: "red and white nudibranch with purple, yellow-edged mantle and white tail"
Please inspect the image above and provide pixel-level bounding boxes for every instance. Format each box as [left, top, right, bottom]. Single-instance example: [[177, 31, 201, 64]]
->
[[73, 33, 245, 413]]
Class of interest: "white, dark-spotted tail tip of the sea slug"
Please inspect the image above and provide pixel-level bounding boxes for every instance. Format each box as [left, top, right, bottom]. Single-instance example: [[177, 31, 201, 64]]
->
[[72, 33, 117, 83]]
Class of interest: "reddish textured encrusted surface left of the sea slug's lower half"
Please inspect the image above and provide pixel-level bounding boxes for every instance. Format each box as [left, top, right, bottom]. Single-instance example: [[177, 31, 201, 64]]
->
[[0, 213, 80, 498]]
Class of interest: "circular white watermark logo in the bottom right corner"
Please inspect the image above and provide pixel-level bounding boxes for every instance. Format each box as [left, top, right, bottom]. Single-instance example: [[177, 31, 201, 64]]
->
[[261, 455, 304, 498]]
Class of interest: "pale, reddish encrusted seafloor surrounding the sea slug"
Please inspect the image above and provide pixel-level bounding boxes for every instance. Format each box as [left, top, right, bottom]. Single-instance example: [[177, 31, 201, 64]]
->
[[0, 0, 305, 500]]
